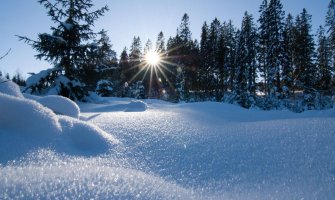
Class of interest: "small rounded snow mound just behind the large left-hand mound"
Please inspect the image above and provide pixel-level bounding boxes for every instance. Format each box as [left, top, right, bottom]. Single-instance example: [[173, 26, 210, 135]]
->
[[36, 95, 80, 119]]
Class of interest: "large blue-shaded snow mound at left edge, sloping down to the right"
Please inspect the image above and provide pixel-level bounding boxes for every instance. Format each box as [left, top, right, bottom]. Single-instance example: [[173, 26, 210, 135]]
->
[[0, 93, 118, 163]]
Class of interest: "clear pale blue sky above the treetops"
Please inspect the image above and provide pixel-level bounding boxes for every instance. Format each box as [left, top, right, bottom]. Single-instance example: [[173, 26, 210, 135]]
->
[[0, 0, 329, 77]]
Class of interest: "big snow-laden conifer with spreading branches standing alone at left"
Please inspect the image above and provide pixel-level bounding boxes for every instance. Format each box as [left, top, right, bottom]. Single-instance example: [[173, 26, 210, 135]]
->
[[19, 0, 108, 100]]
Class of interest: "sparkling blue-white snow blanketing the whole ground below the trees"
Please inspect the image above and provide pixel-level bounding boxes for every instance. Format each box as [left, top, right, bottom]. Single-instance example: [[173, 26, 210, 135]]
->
[[0, 79, 335, 199]]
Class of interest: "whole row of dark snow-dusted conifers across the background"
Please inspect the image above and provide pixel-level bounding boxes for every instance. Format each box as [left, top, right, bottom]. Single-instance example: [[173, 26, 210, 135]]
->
[[19, 0, 335, 112]]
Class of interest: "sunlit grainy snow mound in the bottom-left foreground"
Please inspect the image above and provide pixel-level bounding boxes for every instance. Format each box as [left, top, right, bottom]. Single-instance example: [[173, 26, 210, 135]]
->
[[0, 151, 200, 200]]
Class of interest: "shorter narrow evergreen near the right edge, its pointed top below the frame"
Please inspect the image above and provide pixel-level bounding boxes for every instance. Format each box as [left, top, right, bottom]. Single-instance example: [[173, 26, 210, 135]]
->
[[316, 26, 332, 95]]
